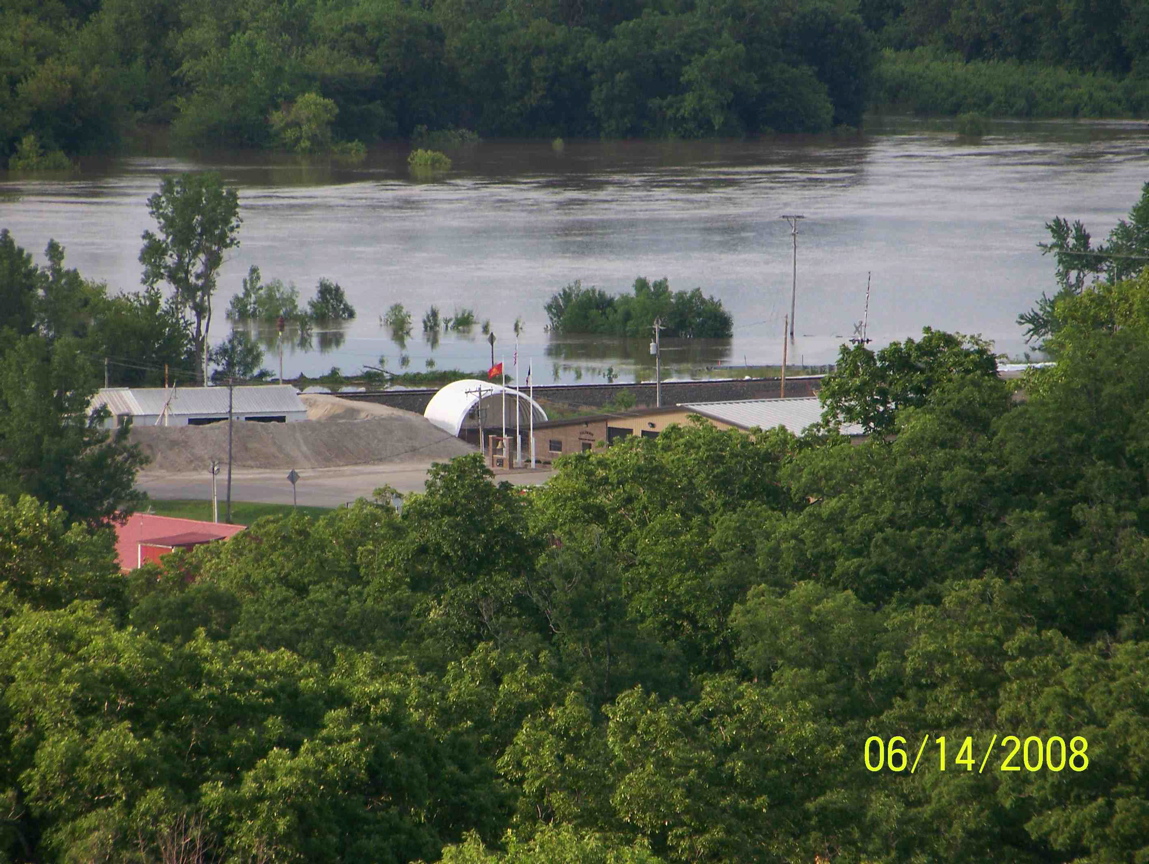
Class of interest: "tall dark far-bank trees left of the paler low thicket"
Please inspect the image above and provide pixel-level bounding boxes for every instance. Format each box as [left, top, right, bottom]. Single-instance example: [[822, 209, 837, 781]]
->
[[0, 0, 872, 164]]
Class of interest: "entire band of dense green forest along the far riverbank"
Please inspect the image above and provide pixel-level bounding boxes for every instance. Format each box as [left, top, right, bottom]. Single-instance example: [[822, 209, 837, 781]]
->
[[0, 0, 1149, 169]]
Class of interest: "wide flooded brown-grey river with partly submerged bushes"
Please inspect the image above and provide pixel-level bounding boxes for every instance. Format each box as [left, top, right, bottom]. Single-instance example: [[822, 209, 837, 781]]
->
[[0, 121, 1149, 383]]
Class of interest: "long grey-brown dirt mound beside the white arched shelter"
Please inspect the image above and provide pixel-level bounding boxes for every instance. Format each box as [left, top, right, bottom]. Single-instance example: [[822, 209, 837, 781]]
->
[[131, 411, 476, 473]]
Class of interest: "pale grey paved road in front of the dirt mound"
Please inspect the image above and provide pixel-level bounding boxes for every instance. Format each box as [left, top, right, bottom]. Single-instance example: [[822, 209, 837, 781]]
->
[[136, 463, 552, 507]]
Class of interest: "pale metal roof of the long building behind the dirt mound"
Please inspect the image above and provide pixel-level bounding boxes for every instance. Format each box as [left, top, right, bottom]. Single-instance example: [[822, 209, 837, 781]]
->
[[92, 384, 307, 417]]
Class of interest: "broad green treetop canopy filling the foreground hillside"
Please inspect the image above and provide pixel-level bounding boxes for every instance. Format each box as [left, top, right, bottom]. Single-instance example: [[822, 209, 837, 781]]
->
[[0, 255, 1149, 864]]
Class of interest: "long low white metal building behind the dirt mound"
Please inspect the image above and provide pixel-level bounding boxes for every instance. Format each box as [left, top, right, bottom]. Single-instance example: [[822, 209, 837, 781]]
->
[[92, 384, 307, 427]]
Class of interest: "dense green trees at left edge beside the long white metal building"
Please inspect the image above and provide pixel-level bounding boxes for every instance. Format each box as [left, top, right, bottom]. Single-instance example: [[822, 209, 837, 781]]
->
[[0, 231, 151, 523]]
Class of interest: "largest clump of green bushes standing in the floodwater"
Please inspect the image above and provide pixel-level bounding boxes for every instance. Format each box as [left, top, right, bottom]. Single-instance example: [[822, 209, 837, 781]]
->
[[545, 276, 734, 339]]
